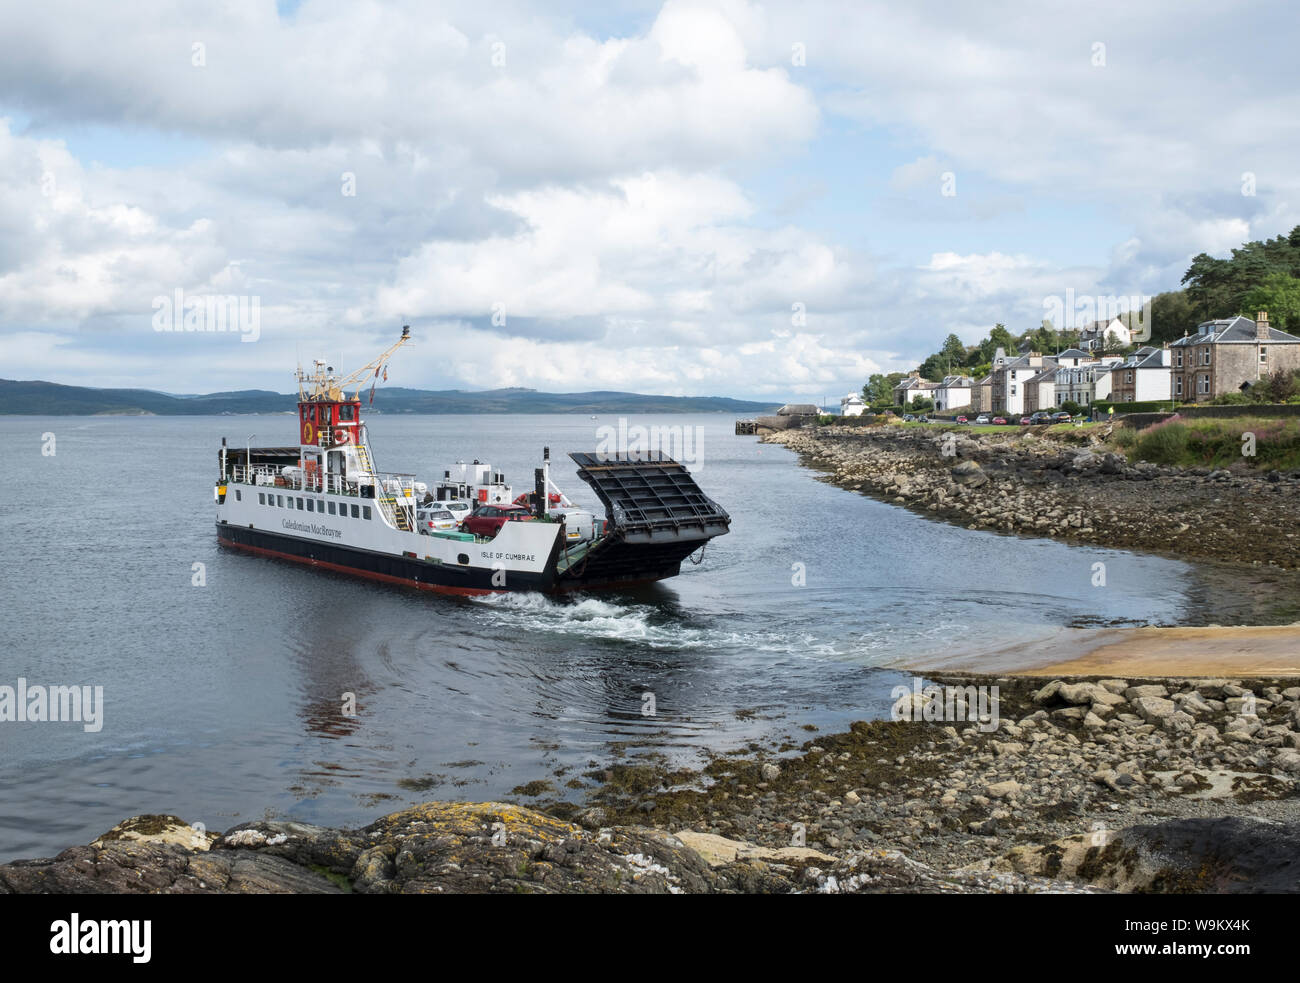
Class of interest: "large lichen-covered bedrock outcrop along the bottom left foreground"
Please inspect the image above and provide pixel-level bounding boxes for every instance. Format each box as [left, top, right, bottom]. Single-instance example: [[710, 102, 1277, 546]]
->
[[0, 802, 722, 895]]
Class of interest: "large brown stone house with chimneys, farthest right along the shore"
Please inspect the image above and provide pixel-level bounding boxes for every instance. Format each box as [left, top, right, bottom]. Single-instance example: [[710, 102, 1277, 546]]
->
[[1166, 311, 1300, 403]]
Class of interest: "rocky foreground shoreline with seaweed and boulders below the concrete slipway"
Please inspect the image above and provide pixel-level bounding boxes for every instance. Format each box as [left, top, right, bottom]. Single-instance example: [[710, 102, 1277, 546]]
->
[[0, 676, 1300, 893]]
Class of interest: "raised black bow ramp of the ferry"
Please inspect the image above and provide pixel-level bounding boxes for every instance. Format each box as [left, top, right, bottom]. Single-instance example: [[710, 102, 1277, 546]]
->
[[556, 451, 731, 590]]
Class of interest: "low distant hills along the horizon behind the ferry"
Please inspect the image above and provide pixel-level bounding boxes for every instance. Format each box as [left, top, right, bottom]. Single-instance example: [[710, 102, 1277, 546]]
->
[[0, 378, 777, 416]]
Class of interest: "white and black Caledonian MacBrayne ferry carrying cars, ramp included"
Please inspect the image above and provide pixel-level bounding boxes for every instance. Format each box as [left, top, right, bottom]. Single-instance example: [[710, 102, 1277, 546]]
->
[[213, 326, 731, 594]]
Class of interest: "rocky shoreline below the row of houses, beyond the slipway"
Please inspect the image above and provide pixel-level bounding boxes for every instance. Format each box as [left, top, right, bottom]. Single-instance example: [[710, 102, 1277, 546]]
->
[[762, 425, 1300, 624]]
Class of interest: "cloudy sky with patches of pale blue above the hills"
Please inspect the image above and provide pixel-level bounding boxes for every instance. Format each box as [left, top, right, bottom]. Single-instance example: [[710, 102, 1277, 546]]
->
[[0, 0, 1300, 400]]
